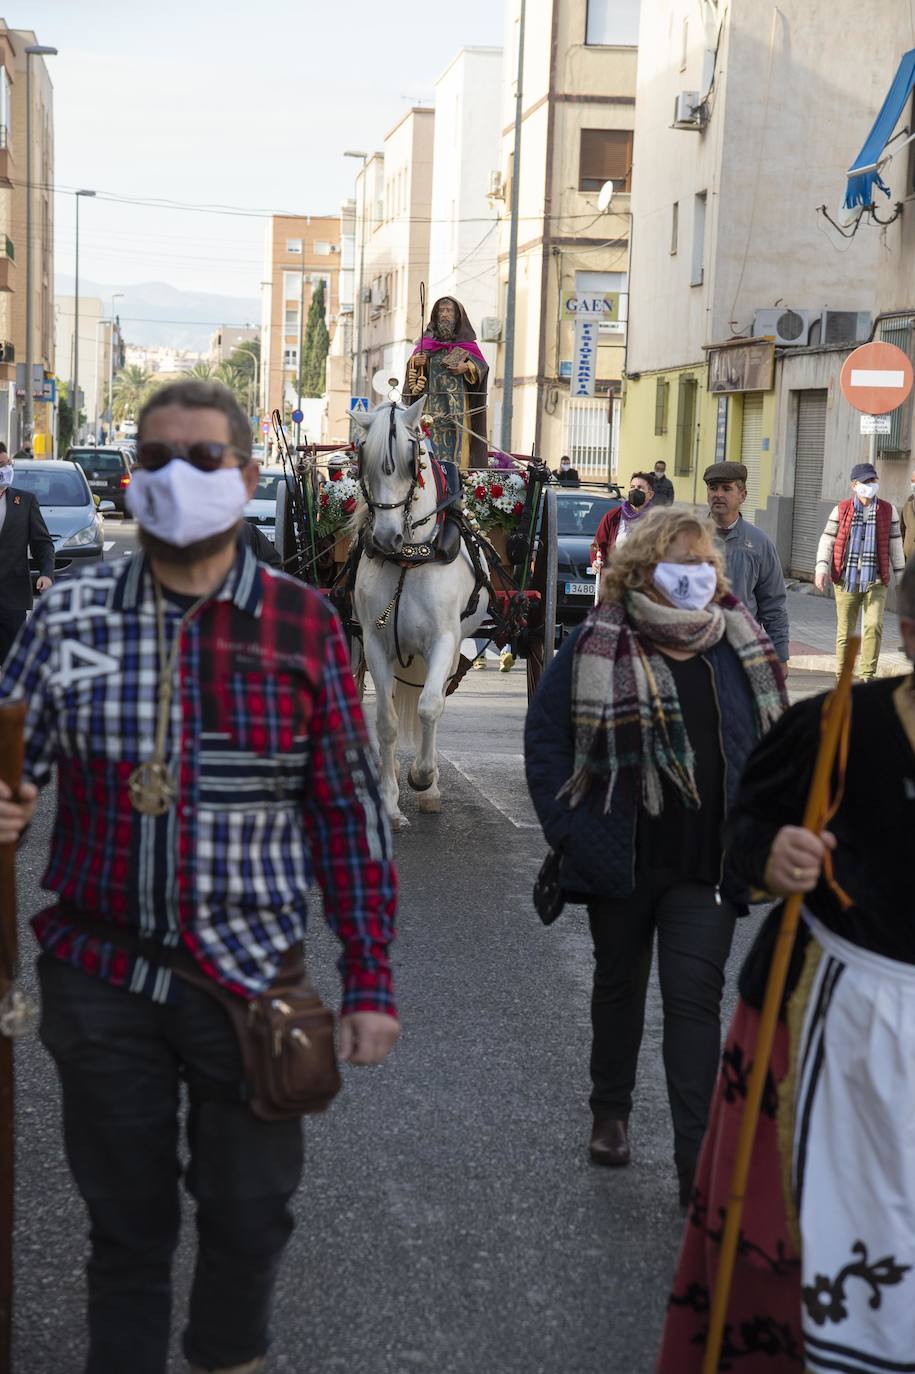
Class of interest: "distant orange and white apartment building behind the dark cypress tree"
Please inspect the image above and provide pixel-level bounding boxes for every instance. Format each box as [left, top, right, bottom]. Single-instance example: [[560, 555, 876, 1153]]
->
[[260, 214, 341, 416]]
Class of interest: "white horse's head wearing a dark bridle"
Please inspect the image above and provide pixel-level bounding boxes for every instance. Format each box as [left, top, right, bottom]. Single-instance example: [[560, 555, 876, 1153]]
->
[[353, 396, 426, 555]]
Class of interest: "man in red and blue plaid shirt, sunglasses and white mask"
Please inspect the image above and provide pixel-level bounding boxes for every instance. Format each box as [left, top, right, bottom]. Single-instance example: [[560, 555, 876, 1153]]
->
[[0, 382, 398, 1374]]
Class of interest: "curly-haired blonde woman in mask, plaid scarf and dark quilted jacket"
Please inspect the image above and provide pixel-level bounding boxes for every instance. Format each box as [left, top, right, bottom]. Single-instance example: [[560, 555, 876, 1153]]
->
[[525, 511, 786, 1205]]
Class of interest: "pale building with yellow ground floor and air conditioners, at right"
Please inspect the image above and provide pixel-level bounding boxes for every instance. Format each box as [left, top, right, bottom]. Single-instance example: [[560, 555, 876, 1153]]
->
[[621, 0, 884, 563]]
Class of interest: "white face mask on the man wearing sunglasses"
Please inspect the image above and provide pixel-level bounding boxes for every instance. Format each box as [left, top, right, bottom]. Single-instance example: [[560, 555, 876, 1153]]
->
[[125, 458, 247, 548]]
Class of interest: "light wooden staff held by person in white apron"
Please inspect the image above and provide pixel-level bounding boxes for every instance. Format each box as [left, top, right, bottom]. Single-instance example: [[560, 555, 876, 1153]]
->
[[702, 638, 860, 1374]]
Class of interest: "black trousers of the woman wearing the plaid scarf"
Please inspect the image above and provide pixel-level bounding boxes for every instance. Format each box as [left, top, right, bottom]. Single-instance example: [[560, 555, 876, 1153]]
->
[[588, 871, 736, 1162]]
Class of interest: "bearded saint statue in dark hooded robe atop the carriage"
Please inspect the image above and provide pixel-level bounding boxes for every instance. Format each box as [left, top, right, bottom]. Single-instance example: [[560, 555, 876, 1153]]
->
[[403, 295, 489, 469]]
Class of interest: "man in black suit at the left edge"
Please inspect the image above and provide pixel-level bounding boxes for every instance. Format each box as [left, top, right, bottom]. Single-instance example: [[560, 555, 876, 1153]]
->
[[0, 448, 54, 665]]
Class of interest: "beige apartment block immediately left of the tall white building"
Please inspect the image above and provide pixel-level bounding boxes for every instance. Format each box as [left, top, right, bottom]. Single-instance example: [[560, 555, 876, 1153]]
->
[[354, 106, 436, 404]]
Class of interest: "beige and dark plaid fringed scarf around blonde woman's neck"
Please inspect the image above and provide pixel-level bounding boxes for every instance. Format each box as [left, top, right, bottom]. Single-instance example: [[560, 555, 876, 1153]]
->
[[559, 592, 787, 816]]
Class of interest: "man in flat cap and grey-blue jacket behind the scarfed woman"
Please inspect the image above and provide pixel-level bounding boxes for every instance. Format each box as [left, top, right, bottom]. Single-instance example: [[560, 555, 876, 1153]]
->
[[702, 463, 789, 665]]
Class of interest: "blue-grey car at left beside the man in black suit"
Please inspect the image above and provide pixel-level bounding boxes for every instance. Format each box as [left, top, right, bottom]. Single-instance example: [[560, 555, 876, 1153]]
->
[[12, 458, 108, 580]]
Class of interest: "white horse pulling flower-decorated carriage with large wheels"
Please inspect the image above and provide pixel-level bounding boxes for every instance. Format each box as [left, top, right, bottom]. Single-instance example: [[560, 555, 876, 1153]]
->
[[267, 400, 558, 824]]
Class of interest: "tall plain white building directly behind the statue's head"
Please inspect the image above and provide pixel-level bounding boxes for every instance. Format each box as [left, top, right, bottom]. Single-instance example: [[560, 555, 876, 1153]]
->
[[427, 48, 504, 387]]
